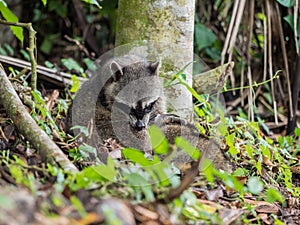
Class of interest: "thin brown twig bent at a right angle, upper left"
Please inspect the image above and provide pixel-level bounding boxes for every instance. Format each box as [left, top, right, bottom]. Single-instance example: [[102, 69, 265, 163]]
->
[[0, 19, 37, 90]]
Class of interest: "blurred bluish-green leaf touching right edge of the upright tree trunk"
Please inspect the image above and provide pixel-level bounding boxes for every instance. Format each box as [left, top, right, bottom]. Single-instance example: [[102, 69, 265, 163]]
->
[[195, 23, 217, 51]]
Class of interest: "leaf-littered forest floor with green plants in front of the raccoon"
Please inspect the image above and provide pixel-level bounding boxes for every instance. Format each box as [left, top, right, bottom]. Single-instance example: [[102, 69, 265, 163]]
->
[[0, 60, 300, 225]]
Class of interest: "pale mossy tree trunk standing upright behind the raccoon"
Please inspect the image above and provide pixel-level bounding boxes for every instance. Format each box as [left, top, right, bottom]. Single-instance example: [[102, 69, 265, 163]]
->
[[116, 0, 195, 120]]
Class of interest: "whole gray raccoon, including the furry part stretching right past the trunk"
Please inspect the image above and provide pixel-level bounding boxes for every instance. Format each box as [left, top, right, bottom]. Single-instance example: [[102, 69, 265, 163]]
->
[[67, 55, 230, 171]]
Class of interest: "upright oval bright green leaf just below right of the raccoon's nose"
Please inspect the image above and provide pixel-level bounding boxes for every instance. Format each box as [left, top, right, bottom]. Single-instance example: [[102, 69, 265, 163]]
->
[[149, 125, 169, 154]]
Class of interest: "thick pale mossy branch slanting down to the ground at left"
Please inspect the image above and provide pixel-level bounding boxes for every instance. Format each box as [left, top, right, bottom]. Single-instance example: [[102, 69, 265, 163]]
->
[[0, 64, 78, 174]]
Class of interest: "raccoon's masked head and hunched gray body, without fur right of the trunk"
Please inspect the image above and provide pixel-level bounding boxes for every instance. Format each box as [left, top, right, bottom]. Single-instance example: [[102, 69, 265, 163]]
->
[[68, 55, 165, 157]]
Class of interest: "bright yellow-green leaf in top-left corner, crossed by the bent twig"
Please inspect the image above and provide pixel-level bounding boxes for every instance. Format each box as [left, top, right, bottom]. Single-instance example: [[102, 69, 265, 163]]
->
[[0, 1, 24, 44]]
